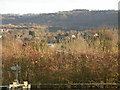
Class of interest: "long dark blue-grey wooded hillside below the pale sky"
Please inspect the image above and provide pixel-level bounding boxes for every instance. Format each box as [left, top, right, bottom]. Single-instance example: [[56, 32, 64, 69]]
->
[[2, 9, 117, 31]]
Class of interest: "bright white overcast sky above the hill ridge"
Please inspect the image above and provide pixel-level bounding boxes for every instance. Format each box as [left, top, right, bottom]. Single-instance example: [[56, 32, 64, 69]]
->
[[0, 0, 119, 14]]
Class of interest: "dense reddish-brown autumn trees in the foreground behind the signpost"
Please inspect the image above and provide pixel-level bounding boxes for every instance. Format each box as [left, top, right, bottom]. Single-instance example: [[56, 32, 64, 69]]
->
[[3, 30, 118, 84]]
